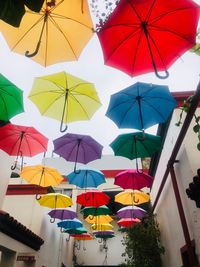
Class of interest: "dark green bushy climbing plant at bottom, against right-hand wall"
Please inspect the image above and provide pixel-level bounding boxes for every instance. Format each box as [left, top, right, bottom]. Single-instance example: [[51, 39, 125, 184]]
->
[[122, 215, 164, 267]]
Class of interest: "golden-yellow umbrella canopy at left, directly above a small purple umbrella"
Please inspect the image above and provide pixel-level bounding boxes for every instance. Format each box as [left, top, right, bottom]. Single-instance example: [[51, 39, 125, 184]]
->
[[37, 193, 73, 209]]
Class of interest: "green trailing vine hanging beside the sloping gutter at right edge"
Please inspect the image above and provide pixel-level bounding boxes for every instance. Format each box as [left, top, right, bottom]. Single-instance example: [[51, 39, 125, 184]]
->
[[176, 95, 200, 151]]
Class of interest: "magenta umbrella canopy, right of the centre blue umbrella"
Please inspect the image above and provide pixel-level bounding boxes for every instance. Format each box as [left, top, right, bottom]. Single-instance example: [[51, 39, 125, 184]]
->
[[114, 170, 153, 190]]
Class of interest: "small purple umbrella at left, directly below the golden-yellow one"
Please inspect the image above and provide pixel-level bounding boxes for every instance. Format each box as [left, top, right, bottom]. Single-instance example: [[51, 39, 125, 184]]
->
[[48, 208, 77, 223]]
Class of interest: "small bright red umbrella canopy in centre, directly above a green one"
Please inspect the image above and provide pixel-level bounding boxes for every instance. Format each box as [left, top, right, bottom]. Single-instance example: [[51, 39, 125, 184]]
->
[[77, 190, 110, 207]]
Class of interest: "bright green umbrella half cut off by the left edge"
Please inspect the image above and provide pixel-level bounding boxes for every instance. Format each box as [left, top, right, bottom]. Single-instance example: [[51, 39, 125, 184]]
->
[[0, 74, 24, 121]]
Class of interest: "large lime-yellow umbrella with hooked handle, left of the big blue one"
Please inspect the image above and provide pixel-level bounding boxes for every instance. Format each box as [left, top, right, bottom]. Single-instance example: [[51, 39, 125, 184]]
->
[[29, 71, 101, 132]]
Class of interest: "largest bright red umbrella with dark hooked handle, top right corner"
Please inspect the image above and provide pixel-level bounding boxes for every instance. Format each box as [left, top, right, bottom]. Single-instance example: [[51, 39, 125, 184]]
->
[[97, 0, 199, 78]]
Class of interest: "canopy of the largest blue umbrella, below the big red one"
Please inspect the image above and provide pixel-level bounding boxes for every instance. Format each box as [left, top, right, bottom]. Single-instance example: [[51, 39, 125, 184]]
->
[[106, 82, 176, 130]]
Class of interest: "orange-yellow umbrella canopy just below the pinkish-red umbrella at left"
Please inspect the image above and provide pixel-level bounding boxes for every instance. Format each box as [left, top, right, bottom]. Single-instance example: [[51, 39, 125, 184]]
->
[[20, 165, 64, 187]]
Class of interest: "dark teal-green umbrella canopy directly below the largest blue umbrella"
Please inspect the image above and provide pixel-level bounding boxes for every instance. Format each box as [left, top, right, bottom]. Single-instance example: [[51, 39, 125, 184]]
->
[[110, 132, 162, 160]]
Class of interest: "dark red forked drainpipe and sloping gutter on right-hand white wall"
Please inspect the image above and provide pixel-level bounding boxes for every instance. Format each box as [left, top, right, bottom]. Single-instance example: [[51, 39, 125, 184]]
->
[[152, 82, 200, 266]]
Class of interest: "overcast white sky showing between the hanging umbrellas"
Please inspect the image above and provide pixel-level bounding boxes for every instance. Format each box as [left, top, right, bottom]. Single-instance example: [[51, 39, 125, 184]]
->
[[0, 1, 200, 164]]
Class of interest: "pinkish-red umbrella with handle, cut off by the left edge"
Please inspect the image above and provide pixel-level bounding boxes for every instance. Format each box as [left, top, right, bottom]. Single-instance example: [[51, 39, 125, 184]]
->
[[0, 123, 48, 169]]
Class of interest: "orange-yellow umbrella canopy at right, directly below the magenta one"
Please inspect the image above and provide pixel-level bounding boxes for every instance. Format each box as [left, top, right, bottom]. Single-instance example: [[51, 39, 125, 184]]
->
[[115, 190, 150, 205]]
